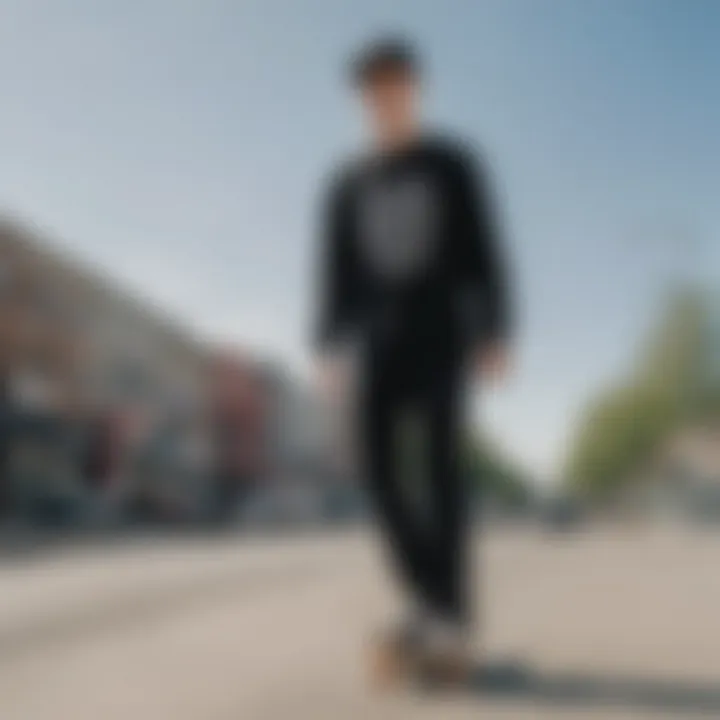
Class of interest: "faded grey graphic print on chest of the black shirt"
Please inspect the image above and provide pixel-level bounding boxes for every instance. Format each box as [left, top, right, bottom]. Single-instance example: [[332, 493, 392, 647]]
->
[[359, 176, 439, 280]]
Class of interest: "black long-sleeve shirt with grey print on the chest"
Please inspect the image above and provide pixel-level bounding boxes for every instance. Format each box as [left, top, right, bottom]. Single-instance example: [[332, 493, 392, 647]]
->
[[316, 138, 510, 362]]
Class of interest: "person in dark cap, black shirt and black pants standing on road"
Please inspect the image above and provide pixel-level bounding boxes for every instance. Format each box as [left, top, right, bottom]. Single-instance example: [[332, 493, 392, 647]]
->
[[315, 38, 511, 682]]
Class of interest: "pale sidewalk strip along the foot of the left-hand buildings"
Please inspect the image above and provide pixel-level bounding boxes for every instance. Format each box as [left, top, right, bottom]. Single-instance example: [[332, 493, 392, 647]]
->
[[0, 534, 360, 656]]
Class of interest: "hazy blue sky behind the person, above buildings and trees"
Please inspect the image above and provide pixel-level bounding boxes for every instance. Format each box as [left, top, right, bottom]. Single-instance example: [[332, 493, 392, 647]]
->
[[0, 0, 720, 474]]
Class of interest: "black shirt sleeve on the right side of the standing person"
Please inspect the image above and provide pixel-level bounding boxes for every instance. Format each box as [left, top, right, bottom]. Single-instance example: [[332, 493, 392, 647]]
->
[[455, 150, 511, 344]]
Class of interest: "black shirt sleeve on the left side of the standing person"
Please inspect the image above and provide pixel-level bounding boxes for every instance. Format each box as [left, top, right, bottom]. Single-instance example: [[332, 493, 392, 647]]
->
[[314, 172, 359, 352]]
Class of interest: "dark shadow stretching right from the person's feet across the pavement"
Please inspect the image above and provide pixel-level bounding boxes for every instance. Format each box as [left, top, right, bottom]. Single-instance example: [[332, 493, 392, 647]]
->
[[472, 663, 720, 717]]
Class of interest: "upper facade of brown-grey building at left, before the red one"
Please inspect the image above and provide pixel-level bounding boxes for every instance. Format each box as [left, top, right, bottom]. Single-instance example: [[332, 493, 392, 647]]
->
[[0, 222, 206, 420]]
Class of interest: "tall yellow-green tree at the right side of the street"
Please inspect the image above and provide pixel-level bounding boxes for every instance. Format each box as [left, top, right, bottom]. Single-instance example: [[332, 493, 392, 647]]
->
[[565, 288, 720, 496]]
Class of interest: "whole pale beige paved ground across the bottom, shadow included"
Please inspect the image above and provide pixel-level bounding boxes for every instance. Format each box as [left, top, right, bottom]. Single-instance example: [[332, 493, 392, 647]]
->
[[0, 531, 720, 720]]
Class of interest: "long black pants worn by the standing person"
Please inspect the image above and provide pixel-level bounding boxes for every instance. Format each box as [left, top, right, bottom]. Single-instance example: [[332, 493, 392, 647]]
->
[[360, 352, 470, 623]]
